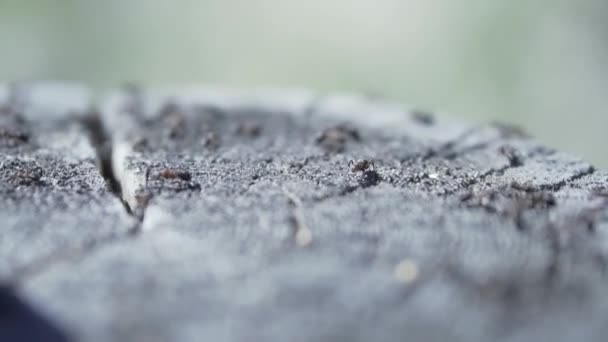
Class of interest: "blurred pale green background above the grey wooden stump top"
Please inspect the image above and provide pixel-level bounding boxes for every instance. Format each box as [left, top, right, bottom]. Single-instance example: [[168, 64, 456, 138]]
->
[[0, 0, 608, 168]]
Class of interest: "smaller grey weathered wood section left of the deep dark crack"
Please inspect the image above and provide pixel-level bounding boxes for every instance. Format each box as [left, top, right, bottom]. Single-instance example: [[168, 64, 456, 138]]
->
[[0, 84, 135, 282]]
